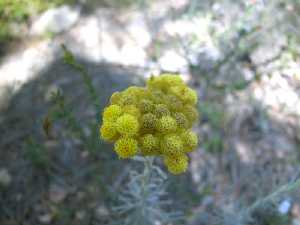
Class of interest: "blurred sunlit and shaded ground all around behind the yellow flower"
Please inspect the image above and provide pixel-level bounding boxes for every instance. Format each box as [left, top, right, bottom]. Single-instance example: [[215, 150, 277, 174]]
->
[[0, 0, 300, 225]]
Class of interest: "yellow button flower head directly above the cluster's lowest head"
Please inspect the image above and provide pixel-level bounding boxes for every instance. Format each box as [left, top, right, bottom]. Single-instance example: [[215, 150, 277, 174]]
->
[[160, 134, 183, 155]]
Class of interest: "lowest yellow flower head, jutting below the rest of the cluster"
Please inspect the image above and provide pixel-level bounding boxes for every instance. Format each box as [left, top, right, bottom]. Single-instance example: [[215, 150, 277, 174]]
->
[[164, 154, 188, 175]]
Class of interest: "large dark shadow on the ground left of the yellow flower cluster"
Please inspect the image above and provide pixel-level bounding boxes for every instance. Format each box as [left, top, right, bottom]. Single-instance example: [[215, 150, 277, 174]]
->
[[0, 53, 146, 225]]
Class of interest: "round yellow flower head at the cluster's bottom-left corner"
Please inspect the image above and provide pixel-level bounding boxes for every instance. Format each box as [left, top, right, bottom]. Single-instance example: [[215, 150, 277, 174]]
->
[[115, 137, 138, 159]]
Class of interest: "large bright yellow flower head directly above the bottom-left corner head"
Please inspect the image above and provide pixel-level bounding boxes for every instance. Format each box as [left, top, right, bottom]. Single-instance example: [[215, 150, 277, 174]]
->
[[116, 114, 139, 136]]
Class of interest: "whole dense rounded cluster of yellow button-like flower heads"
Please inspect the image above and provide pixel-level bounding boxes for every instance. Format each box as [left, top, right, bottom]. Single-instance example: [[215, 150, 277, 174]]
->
[[100, 74, 198, 174]]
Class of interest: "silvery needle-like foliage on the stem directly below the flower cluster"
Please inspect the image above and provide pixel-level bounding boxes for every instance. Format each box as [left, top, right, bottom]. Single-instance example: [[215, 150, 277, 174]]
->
[[113, 157, 182, 225]]
